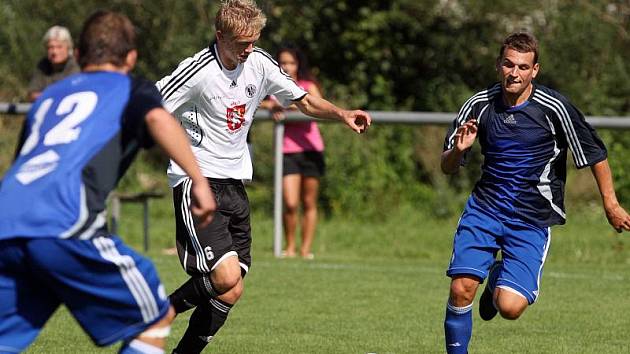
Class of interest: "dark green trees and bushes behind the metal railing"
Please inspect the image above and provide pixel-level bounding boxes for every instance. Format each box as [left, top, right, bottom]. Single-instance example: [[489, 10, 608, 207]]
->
[[0, 0, 630, 217]]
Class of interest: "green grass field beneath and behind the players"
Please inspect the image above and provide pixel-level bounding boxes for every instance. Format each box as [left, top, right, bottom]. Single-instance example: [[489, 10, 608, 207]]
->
[[22, 198, 630, 354]]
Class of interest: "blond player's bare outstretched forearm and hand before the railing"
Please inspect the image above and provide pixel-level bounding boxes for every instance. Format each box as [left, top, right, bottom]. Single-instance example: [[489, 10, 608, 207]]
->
[[295, 94, 372, 134]]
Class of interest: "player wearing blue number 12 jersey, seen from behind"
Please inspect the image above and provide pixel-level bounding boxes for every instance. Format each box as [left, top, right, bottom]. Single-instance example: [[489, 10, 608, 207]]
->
[[0, 11, 216, 354]]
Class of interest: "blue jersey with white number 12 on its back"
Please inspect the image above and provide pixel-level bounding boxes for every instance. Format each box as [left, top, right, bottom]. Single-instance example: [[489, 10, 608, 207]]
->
[[0, 72, 162, 239]]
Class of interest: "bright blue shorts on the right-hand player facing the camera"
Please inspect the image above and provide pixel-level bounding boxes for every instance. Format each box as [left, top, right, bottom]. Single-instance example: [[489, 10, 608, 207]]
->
[[446, 197, 551, 304]]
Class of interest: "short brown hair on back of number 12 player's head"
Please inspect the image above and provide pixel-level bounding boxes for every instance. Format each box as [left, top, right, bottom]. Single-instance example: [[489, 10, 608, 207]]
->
[[77, 10, 136, 68]]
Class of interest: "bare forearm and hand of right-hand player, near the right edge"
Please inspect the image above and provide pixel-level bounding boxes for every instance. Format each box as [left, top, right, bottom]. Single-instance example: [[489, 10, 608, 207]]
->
[[591, 159, 630, 232]]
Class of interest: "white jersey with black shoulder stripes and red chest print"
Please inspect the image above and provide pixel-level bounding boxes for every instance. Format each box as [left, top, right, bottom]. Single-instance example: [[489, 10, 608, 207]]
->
[[156, 44, 306, 187]]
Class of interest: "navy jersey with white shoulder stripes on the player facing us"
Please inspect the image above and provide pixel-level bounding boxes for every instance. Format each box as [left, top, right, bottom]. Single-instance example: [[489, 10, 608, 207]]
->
[[444, 84, 607, 226]]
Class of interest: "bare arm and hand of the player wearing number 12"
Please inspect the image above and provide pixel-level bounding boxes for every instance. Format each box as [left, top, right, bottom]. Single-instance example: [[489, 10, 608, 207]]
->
[[145, 108, 217, 226]]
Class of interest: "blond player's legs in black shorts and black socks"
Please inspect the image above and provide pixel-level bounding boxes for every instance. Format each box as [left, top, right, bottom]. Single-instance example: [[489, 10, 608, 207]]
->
[[170, 180, 251, 353]]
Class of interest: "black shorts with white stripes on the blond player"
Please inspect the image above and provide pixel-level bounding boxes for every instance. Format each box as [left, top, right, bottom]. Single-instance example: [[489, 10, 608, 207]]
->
[[173, 178, 252, 275]]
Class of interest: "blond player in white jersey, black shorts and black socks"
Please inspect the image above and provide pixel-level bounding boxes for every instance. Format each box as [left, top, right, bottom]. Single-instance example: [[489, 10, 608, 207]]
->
[[157, 0, 371, 354]]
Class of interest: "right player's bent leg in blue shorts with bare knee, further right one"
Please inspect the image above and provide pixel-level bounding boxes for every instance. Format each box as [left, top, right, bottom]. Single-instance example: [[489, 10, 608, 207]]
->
[[493, 220, 551, 320]]
